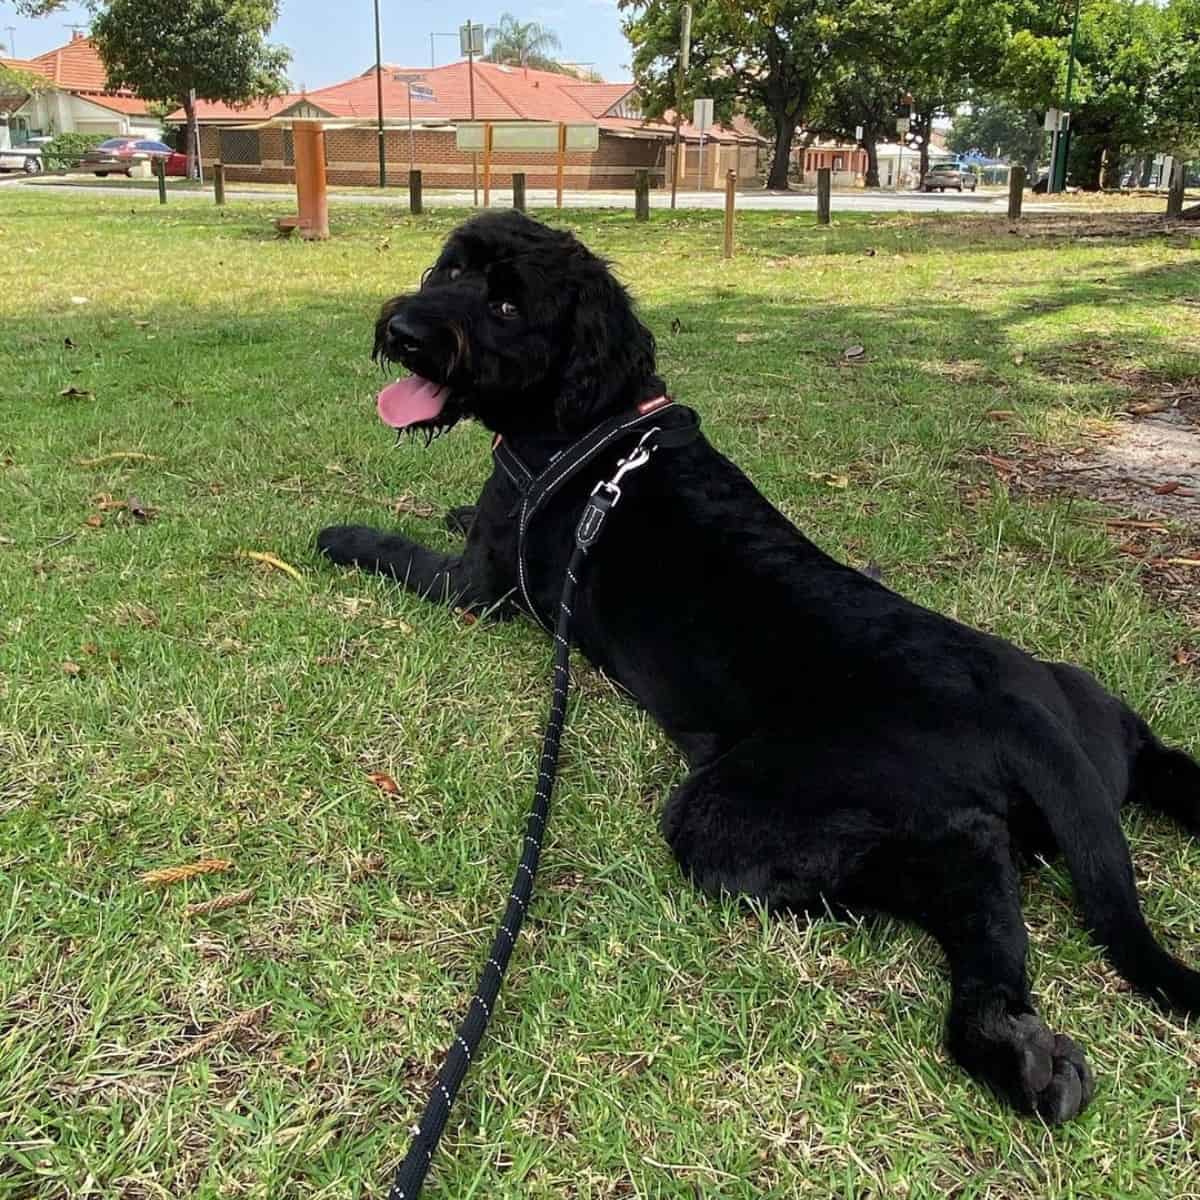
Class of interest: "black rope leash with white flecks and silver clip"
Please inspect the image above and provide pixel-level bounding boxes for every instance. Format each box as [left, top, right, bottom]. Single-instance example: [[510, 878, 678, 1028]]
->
[[388, 414, 698, 1200]]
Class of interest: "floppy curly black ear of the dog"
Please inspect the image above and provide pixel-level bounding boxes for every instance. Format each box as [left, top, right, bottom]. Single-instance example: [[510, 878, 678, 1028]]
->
[[554, 263, 655, 433]]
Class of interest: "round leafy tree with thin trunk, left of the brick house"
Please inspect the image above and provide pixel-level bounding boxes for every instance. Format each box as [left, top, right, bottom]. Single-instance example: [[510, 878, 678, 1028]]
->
[[91, 0, 292, 174]]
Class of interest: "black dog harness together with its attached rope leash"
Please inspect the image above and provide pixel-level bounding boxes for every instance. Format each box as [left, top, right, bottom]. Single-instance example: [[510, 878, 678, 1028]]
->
[[388, 396, 700, 1200]]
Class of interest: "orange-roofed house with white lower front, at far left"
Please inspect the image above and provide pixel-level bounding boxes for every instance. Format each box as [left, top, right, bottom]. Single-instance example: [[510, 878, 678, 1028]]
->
[[0, 31, 162, 143]]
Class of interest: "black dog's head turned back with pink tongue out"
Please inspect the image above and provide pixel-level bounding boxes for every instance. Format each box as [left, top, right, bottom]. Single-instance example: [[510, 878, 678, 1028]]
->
[[374, 211, 662, 436]]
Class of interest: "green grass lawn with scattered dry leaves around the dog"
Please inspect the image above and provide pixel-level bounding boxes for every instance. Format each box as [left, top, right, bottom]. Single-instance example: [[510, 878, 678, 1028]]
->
[[0, 190, 1200, 1200]]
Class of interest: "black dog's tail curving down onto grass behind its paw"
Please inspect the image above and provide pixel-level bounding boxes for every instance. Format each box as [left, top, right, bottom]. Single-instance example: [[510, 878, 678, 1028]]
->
[[1017, 713, 1200, 1013]]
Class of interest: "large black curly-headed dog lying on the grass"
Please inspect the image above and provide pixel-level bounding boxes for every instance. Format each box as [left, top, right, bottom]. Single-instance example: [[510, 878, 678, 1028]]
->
[[318, 214, 1200, 1122]]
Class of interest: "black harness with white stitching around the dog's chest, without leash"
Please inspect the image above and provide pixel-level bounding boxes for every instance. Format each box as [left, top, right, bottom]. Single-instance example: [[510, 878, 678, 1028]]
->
[[492, 396, 700, 632]]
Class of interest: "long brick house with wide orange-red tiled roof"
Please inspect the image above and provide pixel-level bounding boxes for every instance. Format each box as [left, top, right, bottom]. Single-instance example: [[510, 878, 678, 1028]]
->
[[167, 61, 762, 188]]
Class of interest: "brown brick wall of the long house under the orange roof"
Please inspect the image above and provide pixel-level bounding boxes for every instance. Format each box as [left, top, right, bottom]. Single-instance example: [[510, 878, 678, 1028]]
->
[[200, 127, 666, 191]]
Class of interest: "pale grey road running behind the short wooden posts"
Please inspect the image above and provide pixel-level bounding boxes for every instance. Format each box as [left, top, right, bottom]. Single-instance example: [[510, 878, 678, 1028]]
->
[[5, 176, 1069, 215]]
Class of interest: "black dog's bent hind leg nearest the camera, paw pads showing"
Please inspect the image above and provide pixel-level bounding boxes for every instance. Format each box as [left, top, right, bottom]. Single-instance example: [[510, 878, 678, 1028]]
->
[[662, 734, 1092, 1122]]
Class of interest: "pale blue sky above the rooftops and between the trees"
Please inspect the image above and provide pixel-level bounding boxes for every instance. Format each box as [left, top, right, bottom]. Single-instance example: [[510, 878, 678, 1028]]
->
[[0, 0, 630, 89]]
